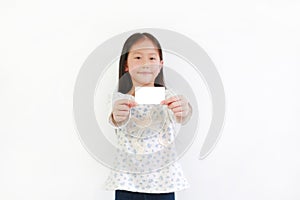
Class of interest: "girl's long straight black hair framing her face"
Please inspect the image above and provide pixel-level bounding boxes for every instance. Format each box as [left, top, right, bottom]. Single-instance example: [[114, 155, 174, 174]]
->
[[118, 33, 166, 94]]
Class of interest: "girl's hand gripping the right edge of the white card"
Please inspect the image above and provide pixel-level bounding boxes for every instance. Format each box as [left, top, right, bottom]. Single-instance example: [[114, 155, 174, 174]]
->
[[160, 95, 191, 123]]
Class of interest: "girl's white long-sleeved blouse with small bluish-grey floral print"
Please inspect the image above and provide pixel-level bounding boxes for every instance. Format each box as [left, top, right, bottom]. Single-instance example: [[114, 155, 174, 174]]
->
[[105, 89, 191, 193]]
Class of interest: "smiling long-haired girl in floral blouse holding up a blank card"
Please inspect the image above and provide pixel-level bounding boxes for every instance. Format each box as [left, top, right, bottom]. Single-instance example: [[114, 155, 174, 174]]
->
[[106, 33, 192, 200]]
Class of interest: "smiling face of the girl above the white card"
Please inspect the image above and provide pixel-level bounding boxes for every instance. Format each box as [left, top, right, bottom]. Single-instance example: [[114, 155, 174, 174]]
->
[[125, 38, 163, 87]]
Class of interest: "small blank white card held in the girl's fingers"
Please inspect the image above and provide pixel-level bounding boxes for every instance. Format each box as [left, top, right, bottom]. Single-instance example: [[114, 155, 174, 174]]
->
[[135, 87, 165, 104]]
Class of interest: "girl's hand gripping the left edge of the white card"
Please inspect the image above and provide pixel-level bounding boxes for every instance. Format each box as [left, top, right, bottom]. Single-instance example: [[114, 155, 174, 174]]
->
[[112, 99, 138, 124]]
